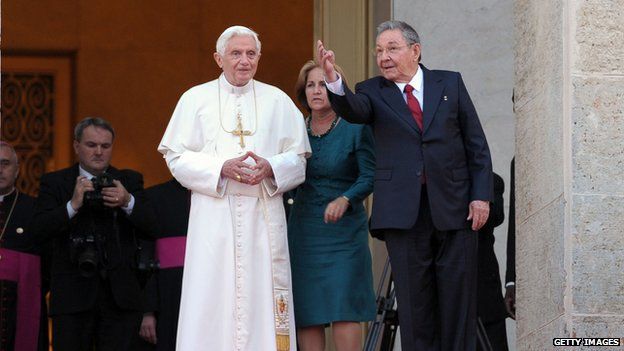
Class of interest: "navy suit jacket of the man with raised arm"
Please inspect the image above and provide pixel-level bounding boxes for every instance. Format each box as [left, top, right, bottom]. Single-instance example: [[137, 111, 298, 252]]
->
[[328, 65, 492, 235]]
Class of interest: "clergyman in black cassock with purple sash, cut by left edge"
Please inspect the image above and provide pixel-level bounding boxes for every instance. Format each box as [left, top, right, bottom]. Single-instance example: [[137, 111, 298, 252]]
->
[[0, 142, 48, 351]]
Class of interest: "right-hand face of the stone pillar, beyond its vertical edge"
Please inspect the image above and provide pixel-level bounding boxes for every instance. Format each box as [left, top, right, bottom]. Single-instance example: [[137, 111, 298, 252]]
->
[[564, 0, 624, 349]]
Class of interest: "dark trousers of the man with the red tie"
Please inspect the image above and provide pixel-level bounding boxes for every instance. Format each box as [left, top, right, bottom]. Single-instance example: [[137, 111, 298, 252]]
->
[[385, 189, 478, 351]]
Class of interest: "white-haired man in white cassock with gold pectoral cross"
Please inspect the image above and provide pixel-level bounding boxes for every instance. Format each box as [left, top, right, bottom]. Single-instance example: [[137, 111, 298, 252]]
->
[[158, 26, 310, 351]]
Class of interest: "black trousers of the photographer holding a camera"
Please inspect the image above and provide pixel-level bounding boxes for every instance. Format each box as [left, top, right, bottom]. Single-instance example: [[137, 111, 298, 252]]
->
[[52, 280, 142, 351]]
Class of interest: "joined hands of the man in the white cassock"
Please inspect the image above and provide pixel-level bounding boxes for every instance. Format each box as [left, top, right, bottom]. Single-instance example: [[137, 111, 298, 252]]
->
[[221, 151, 273, 185]]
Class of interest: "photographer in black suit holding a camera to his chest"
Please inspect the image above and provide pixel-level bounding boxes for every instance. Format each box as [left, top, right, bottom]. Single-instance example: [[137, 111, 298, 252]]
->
[[34, 118, 153, 351]]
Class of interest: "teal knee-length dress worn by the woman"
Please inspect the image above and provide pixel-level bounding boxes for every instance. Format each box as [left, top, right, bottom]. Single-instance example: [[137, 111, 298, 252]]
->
[[288, 120, 376, 327]]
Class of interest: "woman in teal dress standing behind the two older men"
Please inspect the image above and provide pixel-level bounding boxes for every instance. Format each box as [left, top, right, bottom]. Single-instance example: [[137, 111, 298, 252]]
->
[[288, 61, 376, 351]]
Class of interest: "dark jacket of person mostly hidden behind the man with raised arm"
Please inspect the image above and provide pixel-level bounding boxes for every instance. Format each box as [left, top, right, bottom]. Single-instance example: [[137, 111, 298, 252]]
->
[[477, 173, 507, 324]]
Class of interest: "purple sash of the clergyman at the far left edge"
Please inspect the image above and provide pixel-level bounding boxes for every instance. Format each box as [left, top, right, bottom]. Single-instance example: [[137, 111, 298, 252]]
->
[[0, 248, 41, 351]]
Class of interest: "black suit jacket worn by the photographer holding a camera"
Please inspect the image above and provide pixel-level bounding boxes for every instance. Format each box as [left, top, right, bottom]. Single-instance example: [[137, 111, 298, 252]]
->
[[34, 164, 153, 315]]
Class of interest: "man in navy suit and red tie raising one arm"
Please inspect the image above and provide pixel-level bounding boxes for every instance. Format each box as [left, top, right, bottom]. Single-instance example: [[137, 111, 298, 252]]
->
[[317, 21, 492, 351]]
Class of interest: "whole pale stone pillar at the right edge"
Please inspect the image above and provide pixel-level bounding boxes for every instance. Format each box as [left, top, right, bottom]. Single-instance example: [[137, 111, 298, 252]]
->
[[514, 0, 624, 350]]
